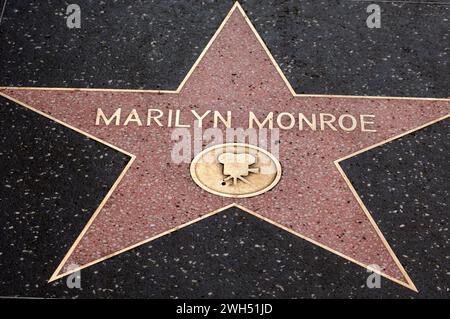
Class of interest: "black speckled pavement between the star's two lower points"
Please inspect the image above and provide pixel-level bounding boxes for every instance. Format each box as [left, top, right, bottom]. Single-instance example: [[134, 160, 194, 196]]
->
[[2, 208, 417, 298]]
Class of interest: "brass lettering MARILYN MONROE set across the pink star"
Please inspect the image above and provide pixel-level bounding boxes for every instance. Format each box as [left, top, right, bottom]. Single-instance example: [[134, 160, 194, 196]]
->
[[95, 108, 376, 132]]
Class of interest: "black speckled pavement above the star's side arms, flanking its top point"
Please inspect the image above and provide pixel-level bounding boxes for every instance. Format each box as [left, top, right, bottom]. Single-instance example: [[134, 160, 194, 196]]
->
[[0, 0, 450, 97]]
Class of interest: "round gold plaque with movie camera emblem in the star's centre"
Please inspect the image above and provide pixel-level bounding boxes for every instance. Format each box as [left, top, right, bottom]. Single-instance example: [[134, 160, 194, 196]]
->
[[191, 143, 281, 198]]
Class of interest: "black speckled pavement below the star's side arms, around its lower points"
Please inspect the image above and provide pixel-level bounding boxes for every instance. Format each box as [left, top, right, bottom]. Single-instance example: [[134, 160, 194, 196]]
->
[[0, 98, 449, 298]]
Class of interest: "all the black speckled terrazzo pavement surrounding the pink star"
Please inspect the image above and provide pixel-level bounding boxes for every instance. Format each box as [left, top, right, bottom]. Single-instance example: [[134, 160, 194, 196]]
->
[[0, 1, 450, 298]]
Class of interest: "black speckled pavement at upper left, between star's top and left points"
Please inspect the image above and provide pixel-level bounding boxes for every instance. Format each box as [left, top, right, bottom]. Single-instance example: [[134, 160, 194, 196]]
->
[[0, 0, 231, 89]]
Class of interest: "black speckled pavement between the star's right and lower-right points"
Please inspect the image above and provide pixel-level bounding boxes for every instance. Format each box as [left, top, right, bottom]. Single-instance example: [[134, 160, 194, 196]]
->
[[343, 119, 450, 298]]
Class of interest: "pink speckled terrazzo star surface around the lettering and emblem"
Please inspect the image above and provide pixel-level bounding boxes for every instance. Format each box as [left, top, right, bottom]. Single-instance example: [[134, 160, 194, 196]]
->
[[2, 4, 450, 289]]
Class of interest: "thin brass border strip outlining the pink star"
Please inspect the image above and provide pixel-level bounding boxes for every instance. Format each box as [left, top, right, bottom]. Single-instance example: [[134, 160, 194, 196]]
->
[[0, 2, 450, 292]]
